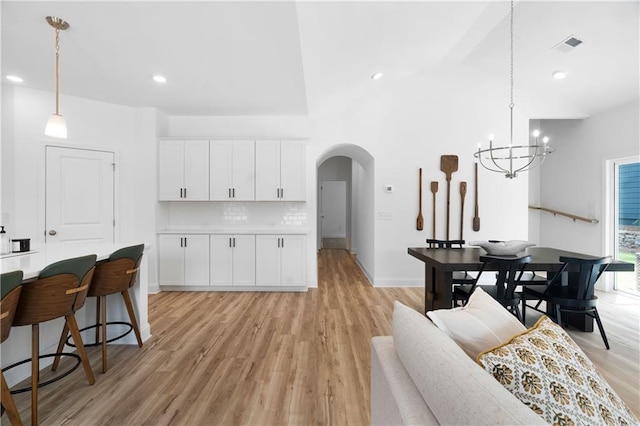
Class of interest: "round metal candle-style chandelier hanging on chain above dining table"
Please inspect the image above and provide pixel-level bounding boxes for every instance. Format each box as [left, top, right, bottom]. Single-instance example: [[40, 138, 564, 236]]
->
[[473, 0, 555, 179]]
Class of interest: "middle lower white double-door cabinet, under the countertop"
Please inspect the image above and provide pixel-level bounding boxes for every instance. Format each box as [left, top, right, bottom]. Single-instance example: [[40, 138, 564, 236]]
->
[[210, 235, 256, 286]]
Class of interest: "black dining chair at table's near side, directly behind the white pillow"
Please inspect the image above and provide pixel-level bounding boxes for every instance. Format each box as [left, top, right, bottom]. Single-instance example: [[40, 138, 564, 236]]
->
[[453, 255, 531, 322]]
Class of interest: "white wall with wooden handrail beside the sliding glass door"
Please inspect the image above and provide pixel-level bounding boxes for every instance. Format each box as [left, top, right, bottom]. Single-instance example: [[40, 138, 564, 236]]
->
[[537, 101, 640, 256]]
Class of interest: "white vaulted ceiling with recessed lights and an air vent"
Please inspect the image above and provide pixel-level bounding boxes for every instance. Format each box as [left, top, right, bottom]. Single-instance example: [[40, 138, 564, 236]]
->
[[0, 1, 640, 118]]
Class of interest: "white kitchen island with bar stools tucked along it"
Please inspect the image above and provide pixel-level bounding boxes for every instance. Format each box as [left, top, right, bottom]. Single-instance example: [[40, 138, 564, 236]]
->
[[0, 242, 151, 386]]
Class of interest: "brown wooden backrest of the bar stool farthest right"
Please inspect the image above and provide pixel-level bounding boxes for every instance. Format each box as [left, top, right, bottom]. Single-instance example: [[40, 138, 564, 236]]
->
[[88, 244, 144, 297]]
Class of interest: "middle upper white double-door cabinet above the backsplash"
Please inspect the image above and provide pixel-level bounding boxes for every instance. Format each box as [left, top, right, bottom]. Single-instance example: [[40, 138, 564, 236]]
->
[[209, 140, 255, 201]]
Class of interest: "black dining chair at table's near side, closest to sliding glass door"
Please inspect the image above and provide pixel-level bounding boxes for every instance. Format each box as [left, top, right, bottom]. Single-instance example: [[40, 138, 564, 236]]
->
[[522, 256, 611, 349]]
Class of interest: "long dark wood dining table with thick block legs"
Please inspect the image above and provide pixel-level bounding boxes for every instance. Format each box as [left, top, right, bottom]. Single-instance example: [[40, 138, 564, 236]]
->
[[408, 247, 635, 331]]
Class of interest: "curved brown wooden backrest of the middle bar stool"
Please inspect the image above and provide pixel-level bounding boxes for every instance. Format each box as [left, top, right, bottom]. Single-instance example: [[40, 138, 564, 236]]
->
[[13, 254, 96, 325]]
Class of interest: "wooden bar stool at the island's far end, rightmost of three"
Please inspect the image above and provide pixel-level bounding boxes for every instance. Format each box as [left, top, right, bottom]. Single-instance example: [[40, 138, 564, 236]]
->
[[52, 244, 144, 373]]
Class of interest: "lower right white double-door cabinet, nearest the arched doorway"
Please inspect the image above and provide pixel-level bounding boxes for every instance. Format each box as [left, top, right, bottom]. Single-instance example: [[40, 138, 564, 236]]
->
[[256, 235, 307, 286]]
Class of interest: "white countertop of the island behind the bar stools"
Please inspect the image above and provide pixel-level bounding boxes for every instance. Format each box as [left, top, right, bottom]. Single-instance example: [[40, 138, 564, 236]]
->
[[0, 242, 149, 280]]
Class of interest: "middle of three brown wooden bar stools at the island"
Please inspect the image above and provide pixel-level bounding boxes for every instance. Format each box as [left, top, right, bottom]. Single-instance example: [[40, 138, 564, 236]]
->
[[13, 254, 96, 425]]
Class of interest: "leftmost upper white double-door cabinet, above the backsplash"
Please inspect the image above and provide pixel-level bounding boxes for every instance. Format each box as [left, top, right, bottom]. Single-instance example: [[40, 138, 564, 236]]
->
[[158, 140, 209, 201]]
